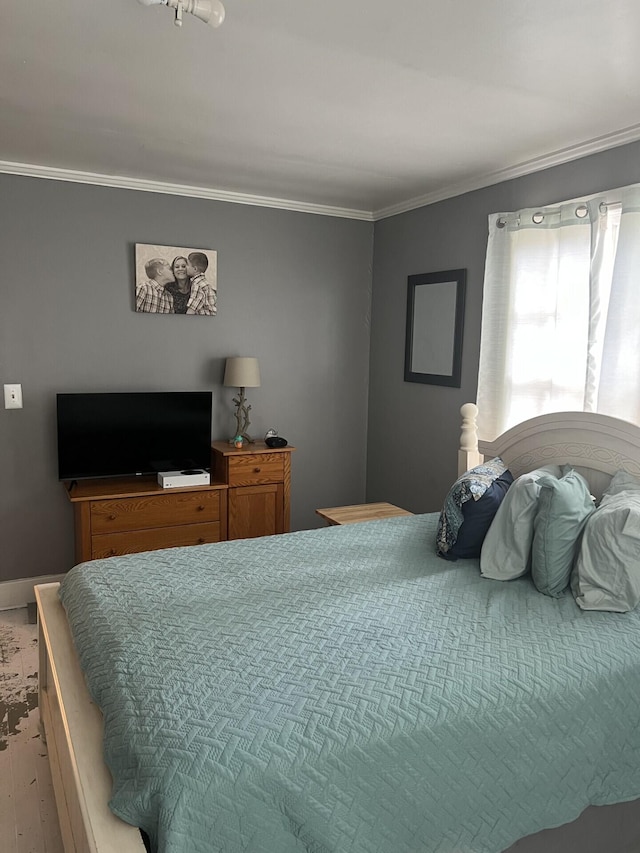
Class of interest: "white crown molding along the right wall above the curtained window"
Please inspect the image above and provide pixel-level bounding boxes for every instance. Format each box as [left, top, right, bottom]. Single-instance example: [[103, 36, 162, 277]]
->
[[372, 124, 640, 222]]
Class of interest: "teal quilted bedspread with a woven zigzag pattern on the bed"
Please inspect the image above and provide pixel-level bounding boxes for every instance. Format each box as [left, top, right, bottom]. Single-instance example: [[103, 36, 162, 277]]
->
[[61, 515, 640, 853]]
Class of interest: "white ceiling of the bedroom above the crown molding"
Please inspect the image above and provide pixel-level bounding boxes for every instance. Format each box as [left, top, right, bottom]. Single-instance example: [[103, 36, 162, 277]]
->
[[0, 0, 640, 218]]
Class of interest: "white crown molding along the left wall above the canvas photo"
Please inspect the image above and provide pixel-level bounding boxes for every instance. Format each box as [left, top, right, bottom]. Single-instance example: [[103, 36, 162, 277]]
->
[[0, 160, 373, 222]]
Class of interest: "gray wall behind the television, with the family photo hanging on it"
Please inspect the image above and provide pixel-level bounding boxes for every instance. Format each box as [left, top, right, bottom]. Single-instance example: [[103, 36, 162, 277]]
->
[[0, 175, 373, 580]]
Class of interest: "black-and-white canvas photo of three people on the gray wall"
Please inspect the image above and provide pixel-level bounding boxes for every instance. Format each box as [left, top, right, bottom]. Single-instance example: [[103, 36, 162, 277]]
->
[[135, 243, 218, 317]]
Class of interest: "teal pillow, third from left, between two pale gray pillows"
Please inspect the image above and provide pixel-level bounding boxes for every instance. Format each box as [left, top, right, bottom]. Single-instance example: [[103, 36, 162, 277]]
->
[[531, 470, 595, 598]]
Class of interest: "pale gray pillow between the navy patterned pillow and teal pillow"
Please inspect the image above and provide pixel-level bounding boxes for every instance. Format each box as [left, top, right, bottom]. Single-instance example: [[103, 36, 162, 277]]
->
[[480, 465, 562, 581]]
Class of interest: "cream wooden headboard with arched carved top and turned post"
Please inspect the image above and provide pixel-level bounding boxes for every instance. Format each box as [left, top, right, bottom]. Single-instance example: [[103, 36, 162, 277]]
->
[[458, 403, 640, 498]]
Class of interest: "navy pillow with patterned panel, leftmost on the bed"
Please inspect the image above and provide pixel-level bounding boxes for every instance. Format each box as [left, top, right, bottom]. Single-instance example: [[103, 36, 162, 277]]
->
[[436, 456, 513, 560]]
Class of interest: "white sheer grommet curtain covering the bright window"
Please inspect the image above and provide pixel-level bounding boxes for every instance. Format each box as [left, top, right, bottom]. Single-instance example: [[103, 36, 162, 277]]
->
[[477, 185, 640, 439]]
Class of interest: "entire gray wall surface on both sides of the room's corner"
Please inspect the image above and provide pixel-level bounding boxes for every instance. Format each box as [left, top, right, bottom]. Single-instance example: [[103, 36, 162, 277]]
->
[[5, 136, 640, 581]]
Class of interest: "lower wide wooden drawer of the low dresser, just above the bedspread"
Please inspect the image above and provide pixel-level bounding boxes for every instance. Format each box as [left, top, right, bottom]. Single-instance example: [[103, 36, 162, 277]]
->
[[91, 521, 220, 560]]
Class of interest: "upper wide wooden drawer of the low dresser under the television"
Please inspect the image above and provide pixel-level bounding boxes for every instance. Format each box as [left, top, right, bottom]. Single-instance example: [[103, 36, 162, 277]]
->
[[91, 491, 220, 532]]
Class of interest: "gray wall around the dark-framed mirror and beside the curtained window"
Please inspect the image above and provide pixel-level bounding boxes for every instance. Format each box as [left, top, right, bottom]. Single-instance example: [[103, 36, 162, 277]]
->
[[367, 143, 640, 512]]
